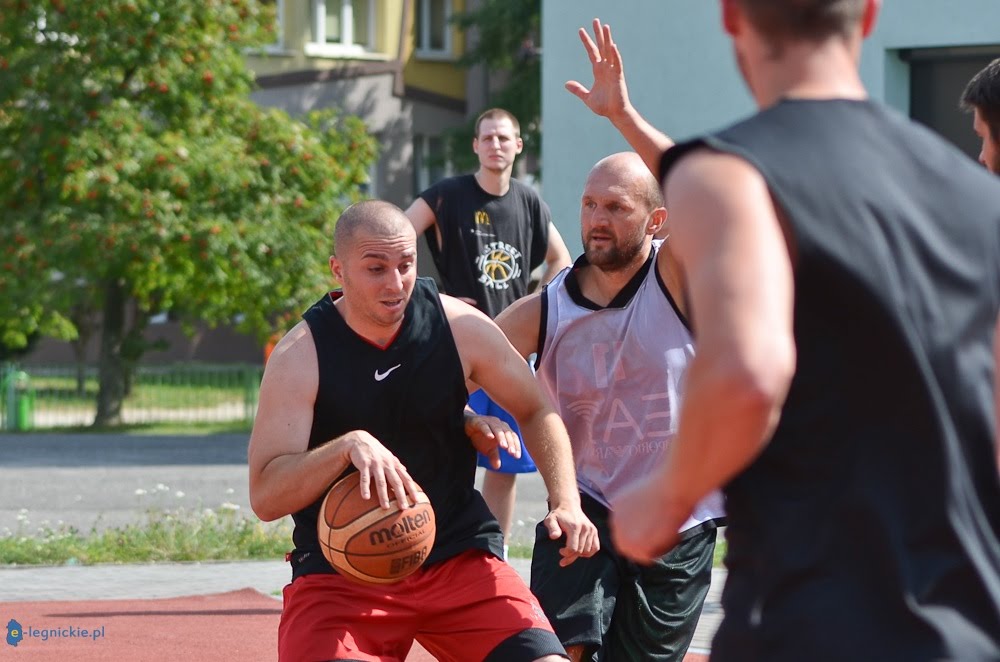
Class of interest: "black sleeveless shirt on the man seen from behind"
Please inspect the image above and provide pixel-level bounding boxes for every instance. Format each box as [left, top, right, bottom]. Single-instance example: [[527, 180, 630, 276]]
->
[[661, 100, 1000, 660]]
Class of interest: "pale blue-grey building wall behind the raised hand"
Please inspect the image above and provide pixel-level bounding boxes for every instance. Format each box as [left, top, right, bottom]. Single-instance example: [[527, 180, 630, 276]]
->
[[542, 0, 1000, 253]]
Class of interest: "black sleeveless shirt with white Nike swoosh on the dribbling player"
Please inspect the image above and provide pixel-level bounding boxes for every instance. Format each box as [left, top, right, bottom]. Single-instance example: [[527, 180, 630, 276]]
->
[[292, 278, 503, 577]]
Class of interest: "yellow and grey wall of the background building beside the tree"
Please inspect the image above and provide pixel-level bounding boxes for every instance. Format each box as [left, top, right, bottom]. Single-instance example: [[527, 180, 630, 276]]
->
[[248, 0, 468, 207]]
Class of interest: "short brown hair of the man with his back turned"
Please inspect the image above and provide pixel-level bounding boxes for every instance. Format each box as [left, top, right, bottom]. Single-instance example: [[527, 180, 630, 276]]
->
[[738, 0, 865, 40]]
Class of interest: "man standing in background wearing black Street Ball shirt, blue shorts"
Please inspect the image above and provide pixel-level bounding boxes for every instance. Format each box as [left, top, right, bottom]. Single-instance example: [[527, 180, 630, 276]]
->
[[406, 108, 571, 556]]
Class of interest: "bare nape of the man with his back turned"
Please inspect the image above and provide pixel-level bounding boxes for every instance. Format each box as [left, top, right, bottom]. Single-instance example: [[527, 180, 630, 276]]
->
[[754, 40, 868, 108]]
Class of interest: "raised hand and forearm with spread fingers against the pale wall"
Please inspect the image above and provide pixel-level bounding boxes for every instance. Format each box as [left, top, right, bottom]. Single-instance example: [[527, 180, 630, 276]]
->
[[566, 18, 674, 179]]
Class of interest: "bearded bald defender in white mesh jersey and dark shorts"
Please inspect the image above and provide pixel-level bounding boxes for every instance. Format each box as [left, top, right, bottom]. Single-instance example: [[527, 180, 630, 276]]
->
[[496, 153, 724, 662]]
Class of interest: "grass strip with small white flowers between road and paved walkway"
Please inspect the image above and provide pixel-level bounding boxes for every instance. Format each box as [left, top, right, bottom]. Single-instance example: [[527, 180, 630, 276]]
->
[[0, 509, 291, 565]]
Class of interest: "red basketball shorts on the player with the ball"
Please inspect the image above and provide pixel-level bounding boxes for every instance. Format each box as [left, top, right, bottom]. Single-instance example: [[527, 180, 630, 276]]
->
[[278, 550, 565, 662]]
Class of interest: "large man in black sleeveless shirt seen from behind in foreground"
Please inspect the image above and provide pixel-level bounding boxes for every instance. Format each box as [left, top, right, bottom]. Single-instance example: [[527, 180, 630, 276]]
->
[[580, 5, 1000, 662]]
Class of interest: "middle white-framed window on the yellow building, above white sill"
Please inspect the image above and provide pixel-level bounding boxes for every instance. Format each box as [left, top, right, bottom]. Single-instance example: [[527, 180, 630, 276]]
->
[[306, 0, 375, 56]]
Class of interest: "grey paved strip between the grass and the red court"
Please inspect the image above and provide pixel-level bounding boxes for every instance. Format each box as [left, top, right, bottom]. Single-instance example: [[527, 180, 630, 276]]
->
[[0, 558, 726, 653]]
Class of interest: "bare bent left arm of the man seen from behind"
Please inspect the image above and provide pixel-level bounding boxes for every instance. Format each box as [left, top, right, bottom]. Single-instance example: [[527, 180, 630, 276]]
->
[[611, 152, 795, 562]]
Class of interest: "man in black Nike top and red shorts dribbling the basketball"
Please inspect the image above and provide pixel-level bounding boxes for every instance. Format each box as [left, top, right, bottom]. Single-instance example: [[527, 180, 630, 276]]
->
[[249, 201, 598, 662]]
